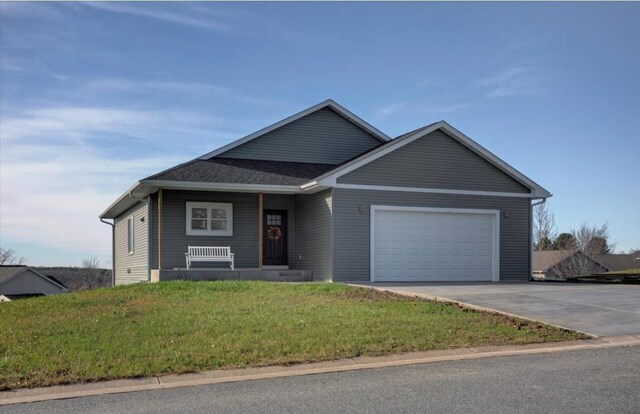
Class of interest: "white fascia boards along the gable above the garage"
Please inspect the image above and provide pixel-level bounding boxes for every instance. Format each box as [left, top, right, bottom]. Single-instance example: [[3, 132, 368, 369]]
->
[[316, 121, 551, 198]]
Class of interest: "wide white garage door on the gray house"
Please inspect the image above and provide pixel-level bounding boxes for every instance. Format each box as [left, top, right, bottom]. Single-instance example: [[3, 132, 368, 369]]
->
[[371, 206, 499, 282]]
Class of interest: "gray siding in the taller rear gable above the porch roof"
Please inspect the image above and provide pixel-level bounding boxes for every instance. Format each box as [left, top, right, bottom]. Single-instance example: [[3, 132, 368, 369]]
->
[[218, 108, 381, 164]]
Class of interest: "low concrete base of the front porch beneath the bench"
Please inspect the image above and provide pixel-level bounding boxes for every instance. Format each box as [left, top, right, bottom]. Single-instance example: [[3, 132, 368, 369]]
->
[[151, 268, 312, 282]]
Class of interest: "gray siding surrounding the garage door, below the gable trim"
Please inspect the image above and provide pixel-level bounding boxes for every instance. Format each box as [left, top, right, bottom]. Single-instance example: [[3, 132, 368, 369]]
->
[[333, 188, 531, 282]]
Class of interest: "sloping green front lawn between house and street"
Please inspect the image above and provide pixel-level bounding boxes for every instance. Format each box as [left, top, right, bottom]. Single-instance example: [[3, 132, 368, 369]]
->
[[0, 281, 584, 390]]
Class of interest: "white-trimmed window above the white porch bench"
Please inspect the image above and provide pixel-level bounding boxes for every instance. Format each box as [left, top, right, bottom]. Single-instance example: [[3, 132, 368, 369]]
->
[[187, 201, 233, 236]]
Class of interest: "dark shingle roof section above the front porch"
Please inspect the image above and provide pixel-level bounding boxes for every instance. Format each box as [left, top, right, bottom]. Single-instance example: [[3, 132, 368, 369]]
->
[[145, 158, 335, 185]]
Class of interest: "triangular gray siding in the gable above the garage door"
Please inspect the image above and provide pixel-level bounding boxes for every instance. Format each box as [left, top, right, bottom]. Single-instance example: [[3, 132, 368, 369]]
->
[[338, 130, 530, 193]]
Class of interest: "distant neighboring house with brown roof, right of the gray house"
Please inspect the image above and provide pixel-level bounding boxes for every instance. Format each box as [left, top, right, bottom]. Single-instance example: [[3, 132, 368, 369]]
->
[[532, 250, 611, 280]]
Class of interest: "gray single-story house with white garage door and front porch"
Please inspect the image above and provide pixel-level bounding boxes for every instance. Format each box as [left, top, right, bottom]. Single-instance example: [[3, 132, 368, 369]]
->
[[100, 100, 551, 284]]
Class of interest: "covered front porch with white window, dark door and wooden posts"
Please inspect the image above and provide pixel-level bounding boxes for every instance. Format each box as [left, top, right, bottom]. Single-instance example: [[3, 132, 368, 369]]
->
[[149, 189, 330, 282]]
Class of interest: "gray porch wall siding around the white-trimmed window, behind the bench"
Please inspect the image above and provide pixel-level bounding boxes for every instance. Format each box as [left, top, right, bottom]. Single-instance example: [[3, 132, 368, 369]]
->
[[162, 190, 258, 269]]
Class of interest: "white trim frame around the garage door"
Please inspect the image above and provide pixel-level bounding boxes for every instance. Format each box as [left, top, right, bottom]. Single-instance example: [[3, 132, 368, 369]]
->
[[369, 204, 500, 283]]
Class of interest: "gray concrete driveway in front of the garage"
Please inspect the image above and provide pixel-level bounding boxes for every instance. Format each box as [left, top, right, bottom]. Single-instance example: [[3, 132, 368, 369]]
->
[[362, 282, 640, 336]]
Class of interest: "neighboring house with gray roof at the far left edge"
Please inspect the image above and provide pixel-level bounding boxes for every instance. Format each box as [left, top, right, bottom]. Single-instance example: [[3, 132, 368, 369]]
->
[[0, 266, 68, 300]]
